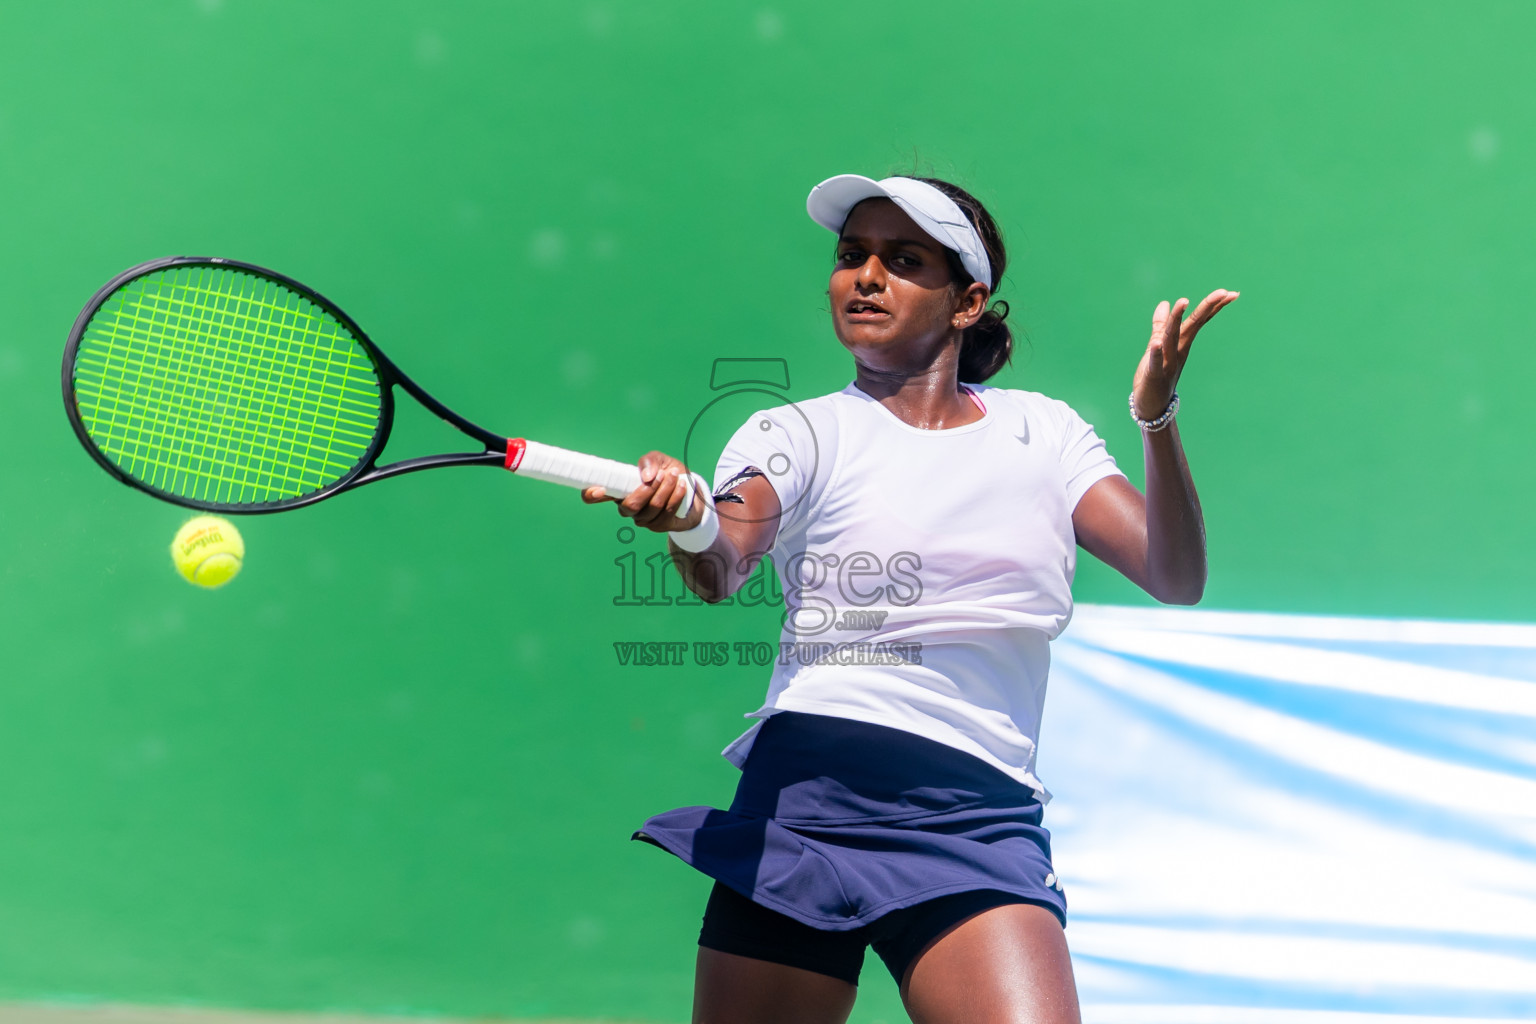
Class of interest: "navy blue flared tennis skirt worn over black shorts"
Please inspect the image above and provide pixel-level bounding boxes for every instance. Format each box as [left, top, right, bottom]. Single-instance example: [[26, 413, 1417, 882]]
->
[[633, 711, 1066, 932]]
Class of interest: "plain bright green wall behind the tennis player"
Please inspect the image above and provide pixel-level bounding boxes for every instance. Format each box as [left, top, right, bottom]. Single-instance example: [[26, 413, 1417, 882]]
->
[[0, 0, 1536, 1021]]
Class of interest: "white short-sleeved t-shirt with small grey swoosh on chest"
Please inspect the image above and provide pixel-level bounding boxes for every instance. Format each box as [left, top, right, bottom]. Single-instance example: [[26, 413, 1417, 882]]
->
[[714, 384, 1120, 798]]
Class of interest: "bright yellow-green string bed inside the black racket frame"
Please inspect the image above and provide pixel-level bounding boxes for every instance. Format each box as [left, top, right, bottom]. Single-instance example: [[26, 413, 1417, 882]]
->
[[75, 266, 382, 504]]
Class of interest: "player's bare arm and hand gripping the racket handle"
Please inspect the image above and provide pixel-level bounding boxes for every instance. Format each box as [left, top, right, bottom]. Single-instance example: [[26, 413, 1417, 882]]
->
[[582, 451, 780, 605]]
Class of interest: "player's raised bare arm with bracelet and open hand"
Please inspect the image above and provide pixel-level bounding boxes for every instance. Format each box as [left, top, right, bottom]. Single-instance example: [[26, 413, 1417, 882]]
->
[[1072, 289, 1238, 605]]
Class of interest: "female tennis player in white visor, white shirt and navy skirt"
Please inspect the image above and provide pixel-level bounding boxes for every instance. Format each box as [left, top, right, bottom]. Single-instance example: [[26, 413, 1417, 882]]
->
[[584, 175, 1236, 1024]]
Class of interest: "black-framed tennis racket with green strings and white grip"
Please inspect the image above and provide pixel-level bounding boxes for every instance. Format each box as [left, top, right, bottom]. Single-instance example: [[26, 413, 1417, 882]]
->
[[63, 256, 663, 516]]
